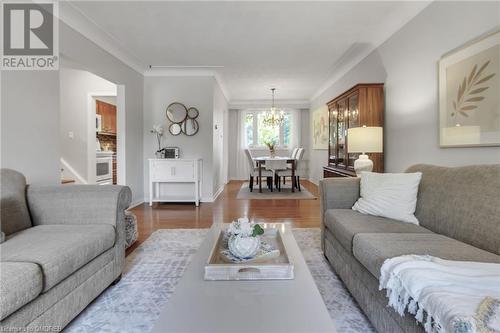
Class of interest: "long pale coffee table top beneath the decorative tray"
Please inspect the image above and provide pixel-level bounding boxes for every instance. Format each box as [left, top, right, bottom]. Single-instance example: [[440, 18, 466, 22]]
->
[[153, 224, 336, 333]]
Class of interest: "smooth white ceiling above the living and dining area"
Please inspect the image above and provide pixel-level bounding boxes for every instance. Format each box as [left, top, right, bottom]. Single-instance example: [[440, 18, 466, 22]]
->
[[64, 1, 429, 101]]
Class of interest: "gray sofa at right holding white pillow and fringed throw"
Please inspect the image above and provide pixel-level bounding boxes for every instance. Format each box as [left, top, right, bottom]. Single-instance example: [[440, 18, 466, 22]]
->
[[320, 165, 500, 333]]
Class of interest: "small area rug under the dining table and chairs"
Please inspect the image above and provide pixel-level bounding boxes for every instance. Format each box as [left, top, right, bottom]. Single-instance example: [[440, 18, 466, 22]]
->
[[236, 182, 316, 200]]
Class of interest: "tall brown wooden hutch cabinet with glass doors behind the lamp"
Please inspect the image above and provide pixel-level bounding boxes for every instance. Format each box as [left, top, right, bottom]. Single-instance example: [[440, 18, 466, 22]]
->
[[323, 83, 384, 178]]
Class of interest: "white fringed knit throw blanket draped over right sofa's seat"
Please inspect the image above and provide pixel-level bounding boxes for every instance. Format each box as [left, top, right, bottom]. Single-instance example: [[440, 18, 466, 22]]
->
[[380, 255, 500, 333]]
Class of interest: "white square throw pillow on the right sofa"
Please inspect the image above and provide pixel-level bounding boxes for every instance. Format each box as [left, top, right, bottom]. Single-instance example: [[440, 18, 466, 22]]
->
[[352, 172, 422, 225]]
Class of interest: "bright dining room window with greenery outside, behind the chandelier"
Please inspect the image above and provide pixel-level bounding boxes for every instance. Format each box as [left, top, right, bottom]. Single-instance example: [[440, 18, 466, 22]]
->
[[245, 111, 292, 147]]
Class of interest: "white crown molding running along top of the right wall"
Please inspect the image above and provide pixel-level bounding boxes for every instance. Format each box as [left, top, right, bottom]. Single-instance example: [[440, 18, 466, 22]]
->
[[310, 0, 434, 102]]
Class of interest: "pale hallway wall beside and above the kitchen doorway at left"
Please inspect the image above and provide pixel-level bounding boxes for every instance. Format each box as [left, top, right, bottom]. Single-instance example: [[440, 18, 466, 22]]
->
[[59, 68, 116, 182]]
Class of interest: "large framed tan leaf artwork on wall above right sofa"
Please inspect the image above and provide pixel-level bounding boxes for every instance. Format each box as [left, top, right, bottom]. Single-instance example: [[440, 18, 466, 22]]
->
[[439, 31, 500, 147]]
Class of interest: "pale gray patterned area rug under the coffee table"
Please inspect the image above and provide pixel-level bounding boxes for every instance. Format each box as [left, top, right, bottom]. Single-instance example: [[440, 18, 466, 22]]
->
[[65, 228, 375, 333]]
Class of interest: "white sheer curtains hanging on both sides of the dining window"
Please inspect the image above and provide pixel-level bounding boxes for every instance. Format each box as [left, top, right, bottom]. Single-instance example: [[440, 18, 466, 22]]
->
[[235, 109, 301, 179]]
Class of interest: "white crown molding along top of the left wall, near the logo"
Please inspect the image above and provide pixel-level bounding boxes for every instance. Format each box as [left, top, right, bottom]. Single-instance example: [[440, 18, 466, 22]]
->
[[59, 1, 146, 74]]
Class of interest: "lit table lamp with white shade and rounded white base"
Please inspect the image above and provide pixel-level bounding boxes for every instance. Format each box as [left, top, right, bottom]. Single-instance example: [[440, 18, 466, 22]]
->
[[347, 126, 384, 176]]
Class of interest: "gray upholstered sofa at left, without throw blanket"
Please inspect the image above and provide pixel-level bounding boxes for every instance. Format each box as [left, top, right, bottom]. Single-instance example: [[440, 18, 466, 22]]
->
[[0, 169, 131, 332]]
